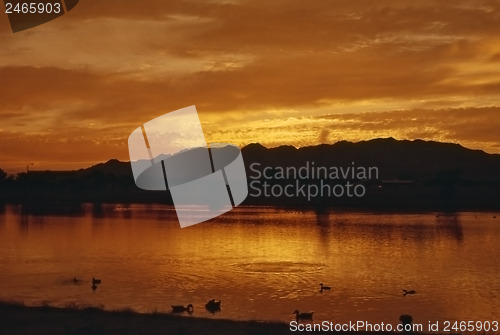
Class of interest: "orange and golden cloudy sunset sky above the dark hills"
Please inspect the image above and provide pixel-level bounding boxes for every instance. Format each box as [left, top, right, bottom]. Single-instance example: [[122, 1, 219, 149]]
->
[[0, 0, 500, 173]]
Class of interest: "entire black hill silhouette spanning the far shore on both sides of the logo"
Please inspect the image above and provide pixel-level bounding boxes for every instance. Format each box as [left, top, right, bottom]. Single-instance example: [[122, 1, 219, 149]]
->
[[0, 138, 500, 210]]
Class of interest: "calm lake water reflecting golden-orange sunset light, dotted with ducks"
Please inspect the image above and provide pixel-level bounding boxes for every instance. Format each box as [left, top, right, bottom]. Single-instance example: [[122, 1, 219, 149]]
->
[[0, 205, 500, 324]]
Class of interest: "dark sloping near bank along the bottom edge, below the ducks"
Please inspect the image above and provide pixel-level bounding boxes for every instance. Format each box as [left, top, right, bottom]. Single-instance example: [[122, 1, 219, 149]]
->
[[0, 302, 454, 335]]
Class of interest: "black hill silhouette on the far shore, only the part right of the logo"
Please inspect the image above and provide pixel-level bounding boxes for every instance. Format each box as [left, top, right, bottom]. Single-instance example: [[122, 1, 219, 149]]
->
[[242, 138, 500, 211]]
